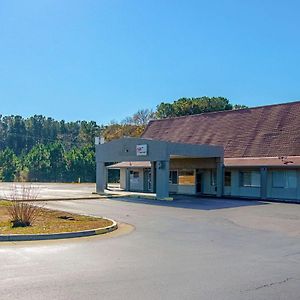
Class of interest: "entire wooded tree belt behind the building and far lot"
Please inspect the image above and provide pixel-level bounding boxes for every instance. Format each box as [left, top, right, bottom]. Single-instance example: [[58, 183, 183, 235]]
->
[[0, 97, 245, 182]]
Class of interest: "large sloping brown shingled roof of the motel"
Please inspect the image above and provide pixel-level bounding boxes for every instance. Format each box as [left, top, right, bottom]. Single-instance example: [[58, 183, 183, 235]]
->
[[142, 101, 300, 158]]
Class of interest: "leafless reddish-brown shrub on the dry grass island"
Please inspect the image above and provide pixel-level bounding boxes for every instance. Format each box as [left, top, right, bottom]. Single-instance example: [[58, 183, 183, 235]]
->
[[7, 184, 42, 227]]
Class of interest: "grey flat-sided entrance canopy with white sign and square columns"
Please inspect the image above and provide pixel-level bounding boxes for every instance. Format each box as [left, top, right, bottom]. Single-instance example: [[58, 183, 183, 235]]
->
[[96, 138, 224, 199]]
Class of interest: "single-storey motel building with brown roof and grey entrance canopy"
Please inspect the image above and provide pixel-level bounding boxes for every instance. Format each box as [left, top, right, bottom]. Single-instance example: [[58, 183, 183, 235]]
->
[[96, 101, 300, 202]]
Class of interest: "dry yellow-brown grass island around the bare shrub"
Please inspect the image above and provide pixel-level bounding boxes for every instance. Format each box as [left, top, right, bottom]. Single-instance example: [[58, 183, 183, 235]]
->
[[0, 201, 112, 234]]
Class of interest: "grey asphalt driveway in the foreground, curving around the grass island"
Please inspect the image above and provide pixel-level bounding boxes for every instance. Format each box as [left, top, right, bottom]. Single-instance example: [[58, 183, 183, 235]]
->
[[0, 198, 300, 300]]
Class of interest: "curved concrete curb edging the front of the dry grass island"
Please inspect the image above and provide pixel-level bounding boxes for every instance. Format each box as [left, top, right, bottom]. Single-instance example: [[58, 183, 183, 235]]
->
[[0, 218, 118, 242]]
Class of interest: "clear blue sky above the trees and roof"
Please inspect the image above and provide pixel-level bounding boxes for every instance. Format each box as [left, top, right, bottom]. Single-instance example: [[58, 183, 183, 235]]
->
[[0, 0, 300, 123]]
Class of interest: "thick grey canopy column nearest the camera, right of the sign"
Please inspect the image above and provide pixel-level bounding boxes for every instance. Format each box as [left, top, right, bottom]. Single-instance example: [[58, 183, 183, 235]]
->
[[156, 160, 169, 199]]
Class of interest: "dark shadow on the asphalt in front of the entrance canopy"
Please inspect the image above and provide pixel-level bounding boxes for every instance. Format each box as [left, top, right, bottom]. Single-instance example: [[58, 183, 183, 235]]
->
[[109, 195, 268, 210]]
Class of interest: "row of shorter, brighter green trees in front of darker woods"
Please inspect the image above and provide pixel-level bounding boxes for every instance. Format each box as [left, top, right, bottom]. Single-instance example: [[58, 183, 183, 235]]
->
[[0, 142, 96, 182]]
